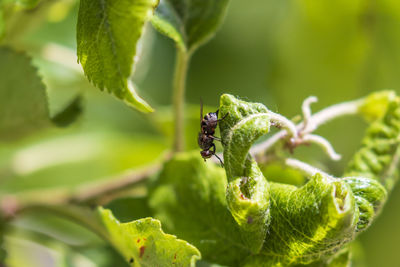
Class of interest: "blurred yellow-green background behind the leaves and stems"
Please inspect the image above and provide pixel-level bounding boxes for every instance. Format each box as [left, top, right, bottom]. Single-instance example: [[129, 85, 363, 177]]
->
[[0, 0, 400, 267]]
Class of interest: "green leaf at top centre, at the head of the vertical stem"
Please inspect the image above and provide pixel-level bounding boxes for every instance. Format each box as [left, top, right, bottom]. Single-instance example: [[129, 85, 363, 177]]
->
[[152, 0, 229, 51]]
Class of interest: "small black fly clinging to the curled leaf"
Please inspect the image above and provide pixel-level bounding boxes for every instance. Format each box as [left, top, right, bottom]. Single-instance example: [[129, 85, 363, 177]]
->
[[197, 102, 228, 166]]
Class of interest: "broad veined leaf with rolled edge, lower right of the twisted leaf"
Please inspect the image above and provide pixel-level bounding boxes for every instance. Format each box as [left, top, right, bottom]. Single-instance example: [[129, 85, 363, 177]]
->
[[248, 174, 358, 266]]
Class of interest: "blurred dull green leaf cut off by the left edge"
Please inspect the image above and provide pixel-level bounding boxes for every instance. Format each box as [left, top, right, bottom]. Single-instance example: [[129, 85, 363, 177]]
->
[[0, 47, 81, 140]]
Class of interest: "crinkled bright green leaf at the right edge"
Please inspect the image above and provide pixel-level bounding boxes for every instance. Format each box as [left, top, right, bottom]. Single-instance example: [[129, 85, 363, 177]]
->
[[344, 91, 400, 231]]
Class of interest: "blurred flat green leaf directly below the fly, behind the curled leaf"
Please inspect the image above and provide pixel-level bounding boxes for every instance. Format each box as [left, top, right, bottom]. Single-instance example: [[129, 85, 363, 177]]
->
[[150, 151, 250, 266]]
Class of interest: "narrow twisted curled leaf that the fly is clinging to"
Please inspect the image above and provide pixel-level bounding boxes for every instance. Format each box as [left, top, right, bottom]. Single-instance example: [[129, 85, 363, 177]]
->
[[219, 94, 270, 253]]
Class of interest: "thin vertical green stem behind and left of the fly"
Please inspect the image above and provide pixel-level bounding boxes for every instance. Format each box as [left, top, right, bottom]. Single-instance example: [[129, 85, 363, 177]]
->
[[172, 48, 190, 152]]
